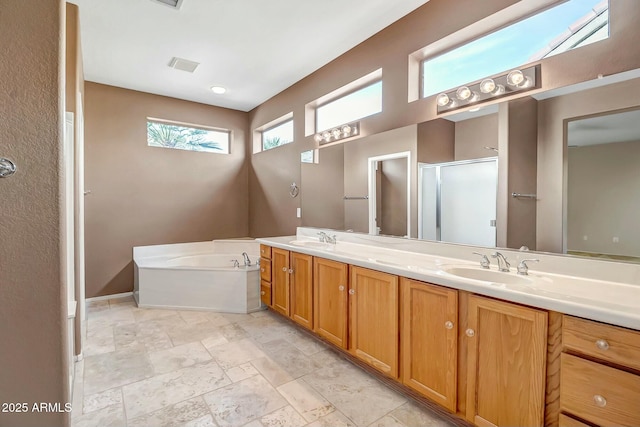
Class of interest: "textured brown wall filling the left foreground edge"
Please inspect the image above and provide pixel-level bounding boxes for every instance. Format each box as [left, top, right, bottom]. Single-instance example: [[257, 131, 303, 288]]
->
[[0, 0, 69, 426]]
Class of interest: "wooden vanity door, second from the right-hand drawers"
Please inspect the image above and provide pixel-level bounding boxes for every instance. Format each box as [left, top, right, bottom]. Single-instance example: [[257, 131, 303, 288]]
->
[[400, 278, 458, 412]]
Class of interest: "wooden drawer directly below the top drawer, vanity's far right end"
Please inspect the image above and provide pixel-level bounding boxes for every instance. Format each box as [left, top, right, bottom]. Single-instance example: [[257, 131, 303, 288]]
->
[[560, 353, 640, 426]]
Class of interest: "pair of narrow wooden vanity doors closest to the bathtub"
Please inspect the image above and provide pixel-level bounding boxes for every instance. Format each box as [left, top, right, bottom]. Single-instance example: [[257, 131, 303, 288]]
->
[[271, 248, 313, 329]]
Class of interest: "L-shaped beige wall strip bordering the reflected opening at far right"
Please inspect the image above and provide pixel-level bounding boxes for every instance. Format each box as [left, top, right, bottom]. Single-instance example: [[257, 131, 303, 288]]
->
[[536, 76, 640, 252]]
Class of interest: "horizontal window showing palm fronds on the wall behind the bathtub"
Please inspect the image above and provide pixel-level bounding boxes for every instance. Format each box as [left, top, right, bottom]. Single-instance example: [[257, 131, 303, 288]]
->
[[147, 119, 231, 154]]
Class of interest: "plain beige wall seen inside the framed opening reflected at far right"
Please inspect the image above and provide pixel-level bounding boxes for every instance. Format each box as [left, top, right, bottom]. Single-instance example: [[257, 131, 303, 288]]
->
[[567, 141, 640, 257]]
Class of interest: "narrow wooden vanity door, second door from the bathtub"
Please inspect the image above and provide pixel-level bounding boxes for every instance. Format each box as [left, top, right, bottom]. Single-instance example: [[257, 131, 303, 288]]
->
[[290, 252, 313, 329]]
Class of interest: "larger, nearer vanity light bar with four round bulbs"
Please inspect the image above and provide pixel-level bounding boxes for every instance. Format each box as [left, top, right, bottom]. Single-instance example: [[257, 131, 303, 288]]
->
[[436, 65, 538, 114]]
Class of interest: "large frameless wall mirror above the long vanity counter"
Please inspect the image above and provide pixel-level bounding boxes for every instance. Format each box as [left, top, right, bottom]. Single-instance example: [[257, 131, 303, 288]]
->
[[301, 70, 640, 261]]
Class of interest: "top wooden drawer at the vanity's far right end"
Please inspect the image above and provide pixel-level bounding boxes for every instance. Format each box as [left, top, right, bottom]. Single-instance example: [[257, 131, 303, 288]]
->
[[562, 316, 640, 370]]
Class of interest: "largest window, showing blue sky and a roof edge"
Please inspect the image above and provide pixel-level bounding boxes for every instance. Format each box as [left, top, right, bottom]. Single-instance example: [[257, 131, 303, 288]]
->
[[422, 0, 609, 97]]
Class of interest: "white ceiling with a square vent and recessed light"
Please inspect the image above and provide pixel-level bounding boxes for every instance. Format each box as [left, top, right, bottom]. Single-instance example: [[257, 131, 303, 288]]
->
[[70, 0, 428, 111]]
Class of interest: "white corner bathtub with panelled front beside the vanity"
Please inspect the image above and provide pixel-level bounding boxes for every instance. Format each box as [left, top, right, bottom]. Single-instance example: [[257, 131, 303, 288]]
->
[[133, 239, 265, 313]]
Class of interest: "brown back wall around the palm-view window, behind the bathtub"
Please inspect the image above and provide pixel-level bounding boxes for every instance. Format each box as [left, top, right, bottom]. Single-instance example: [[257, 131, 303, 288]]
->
[[85, 82, 251, 297]]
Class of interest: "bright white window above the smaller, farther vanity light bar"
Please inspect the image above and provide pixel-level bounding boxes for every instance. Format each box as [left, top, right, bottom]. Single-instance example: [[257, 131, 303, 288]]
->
[[316, 81, 382, 132]]
